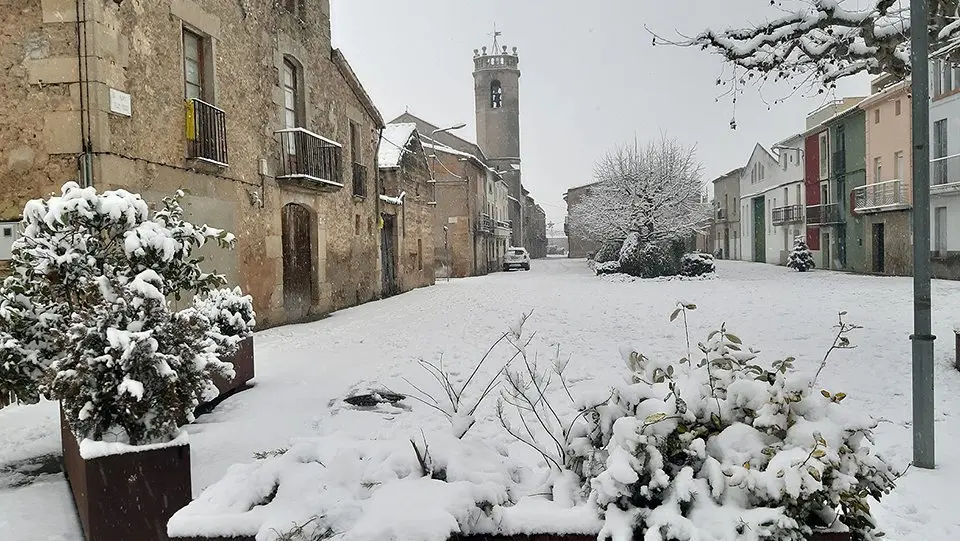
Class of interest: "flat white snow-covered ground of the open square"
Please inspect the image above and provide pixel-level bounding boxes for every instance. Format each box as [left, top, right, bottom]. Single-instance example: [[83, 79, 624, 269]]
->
[[0, 258, 960, 541]]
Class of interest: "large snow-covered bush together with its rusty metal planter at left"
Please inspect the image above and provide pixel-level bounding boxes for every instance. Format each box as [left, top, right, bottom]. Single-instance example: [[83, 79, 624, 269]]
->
[[0, 182, 253, 541]]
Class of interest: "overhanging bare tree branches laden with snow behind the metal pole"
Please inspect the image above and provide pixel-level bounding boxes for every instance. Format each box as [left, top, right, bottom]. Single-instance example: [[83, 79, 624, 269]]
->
[[684, 0, 960, 88]]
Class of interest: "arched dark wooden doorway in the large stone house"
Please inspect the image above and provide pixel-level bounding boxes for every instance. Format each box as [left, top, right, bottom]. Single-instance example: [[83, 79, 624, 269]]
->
[[280, 203, 314, 321]]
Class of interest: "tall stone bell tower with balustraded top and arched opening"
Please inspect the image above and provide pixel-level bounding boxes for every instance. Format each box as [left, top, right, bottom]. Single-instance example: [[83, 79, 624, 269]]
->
[[473, 29, 524, 242]]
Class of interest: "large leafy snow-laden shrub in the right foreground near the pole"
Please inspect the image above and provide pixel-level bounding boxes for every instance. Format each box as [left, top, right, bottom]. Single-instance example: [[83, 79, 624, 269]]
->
[[571, 308, 896, 541]]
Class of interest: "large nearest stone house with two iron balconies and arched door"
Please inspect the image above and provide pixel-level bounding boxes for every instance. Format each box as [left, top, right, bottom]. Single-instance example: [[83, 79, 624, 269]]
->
[[0, 0, 383, 326]]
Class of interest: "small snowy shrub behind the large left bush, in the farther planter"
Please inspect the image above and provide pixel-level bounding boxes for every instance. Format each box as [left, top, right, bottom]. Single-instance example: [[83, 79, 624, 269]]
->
[[193, 287, 257, 359]]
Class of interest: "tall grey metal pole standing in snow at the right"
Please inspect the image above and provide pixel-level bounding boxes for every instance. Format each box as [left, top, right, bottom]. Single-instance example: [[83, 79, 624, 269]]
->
[[910, 0, 936, 468]]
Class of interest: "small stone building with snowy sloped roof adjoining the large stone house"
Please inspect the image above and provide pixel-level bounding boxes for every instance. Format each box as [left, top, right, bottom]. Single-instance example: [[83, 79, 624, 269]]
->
[[377, 123, 436, 297]]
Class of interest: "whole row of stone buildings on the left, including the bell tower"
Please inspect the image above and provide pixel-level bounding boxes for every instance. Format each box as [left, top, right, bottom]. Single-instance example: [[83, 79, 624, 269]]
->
[[0, 0, 546, 326]]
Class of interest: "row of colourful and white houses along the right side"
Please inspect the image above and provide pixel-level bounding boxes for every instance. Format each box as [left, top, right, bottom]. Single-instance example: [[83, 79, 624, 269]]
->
[[700, 55, 960, 279]]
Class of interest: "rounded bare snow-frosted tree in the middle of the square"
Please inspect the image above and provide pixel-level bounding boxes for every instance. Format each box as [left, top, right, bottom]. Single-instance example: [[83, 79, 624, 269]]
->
[[570, 137, 709, 248]]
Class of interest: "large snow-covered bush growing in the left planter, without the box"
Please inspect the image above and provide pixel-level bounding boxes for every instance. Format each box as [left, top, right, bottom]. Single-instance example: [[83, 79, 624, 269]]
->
[[0, 182, 253, 445]]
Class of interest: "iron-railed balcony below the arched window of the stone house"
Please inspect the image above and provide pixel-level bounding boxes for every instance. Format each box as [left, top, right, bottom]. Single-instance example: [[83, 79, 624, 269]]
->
[[276, 128, 343, 189]]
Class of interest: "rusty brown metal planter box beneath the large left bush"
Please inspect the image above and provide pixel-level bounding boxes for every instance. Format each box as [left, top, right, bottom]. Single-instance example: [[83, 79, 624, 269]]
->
[[60, 408, 192, 541]]
